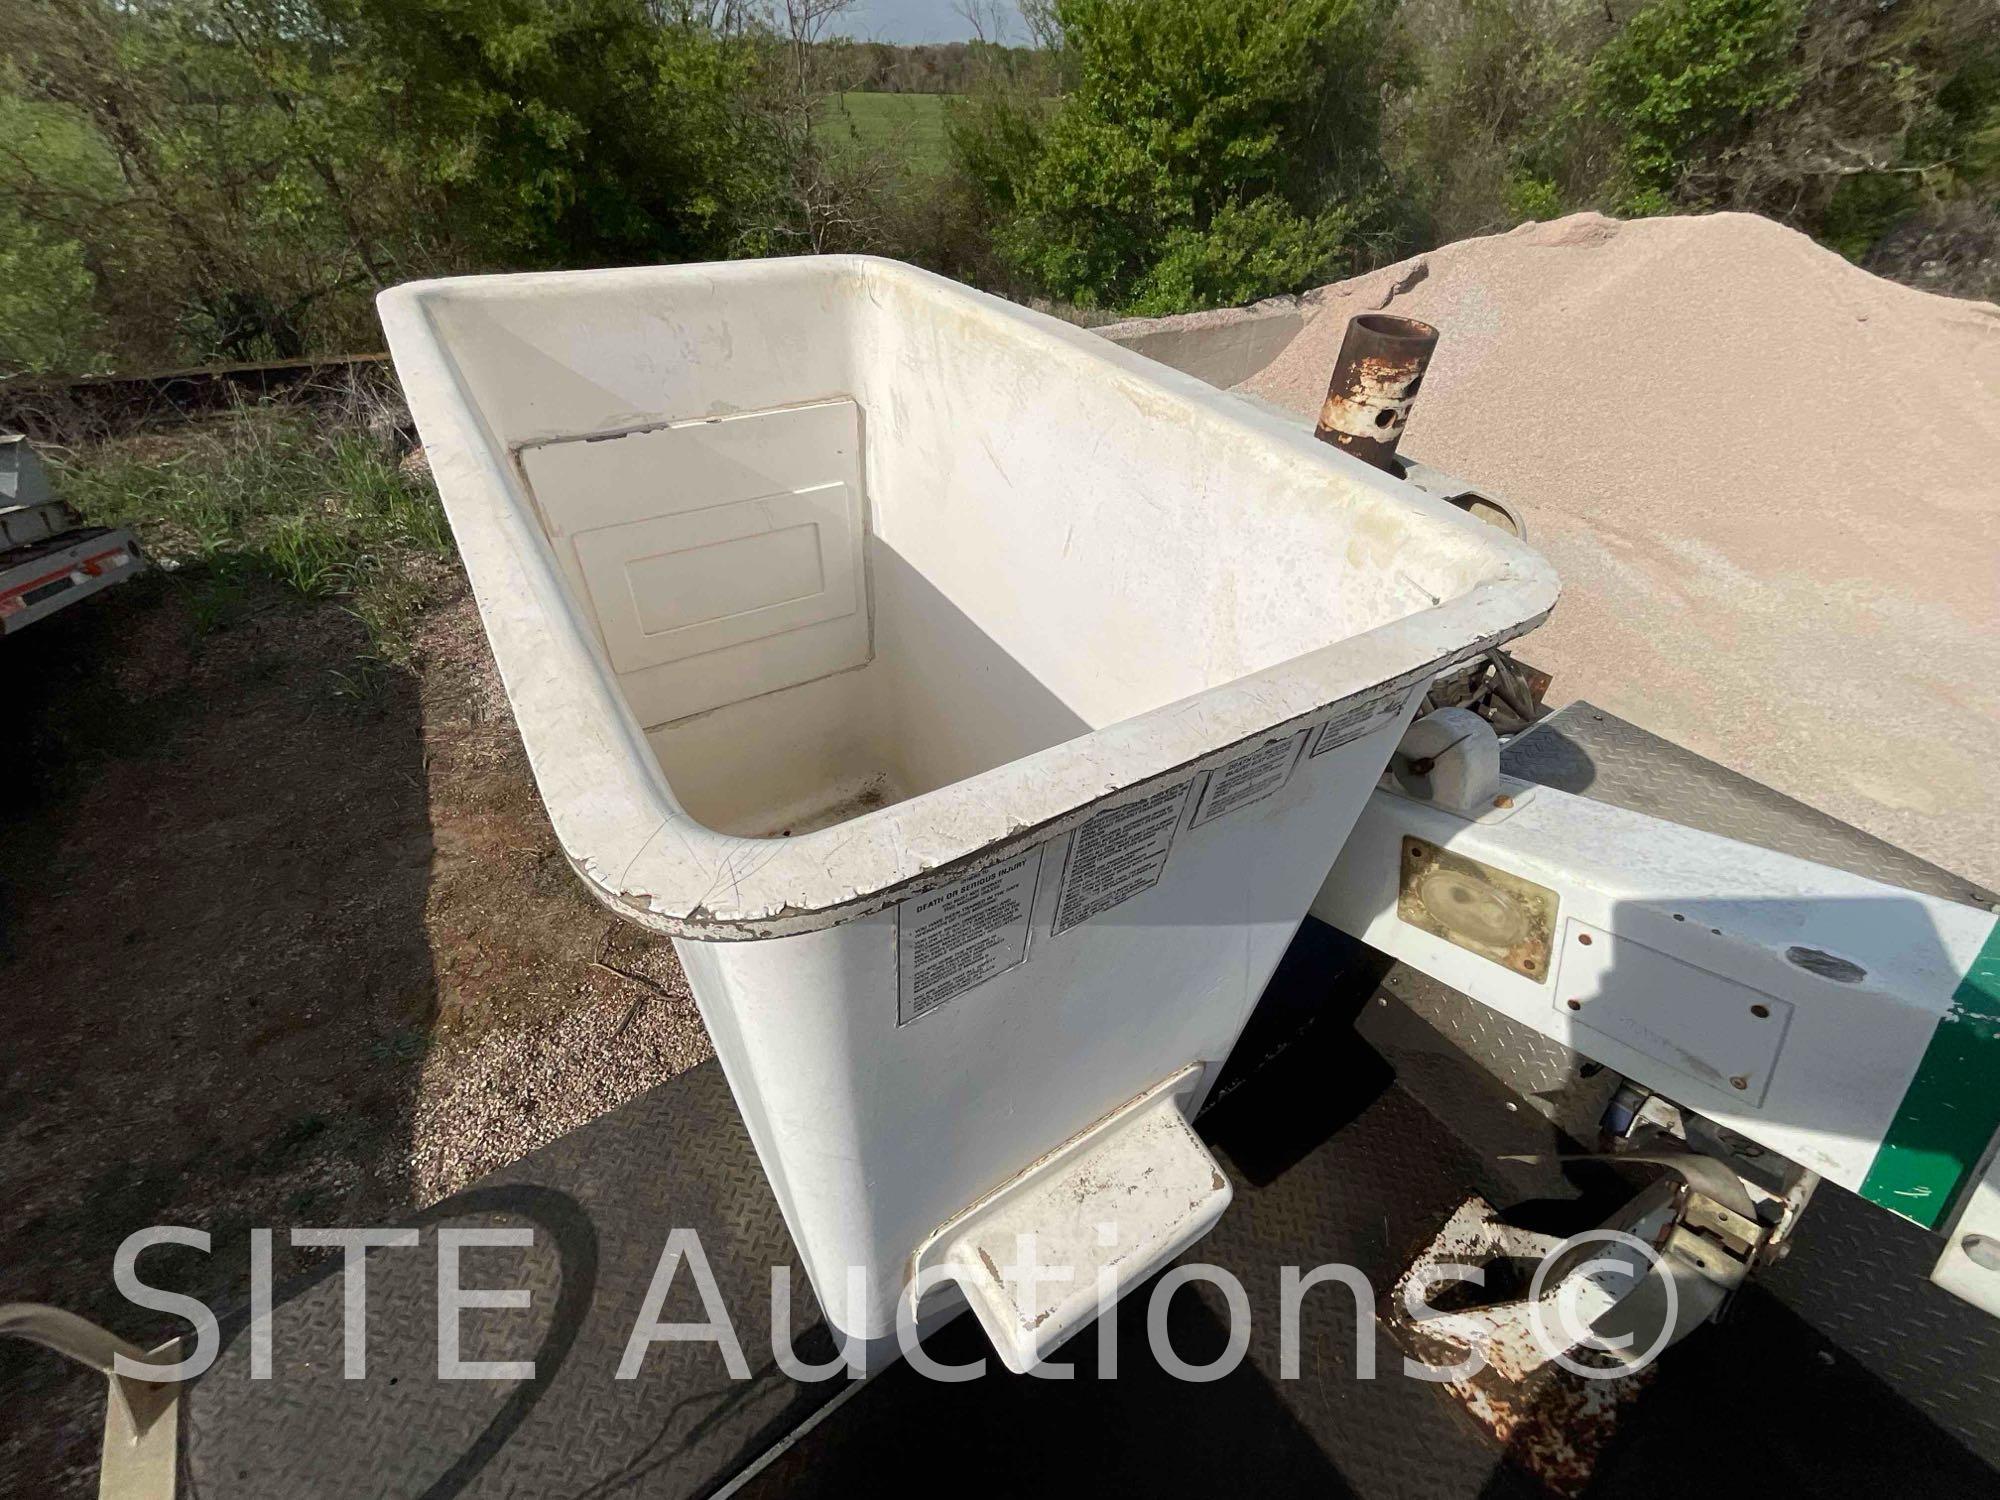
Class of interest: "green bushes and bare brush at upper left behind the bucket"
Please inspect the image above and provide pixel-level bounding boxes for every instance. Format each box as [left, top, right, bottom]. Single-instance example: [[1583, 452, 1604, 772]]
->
[[0, 0, 778, 374]]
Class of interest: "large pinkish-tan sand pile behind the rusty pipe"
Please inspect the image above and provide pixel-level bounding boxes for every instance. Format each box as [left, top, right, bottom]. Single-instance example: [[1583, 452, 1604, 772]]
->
[[1244, 214, 2000, 886]]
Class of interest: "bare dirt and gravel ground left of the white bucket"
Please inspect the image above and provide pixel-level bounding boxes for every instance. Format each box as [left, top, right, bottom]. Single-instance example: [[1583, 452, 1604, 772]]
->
[[0, 574, 708, 1496]]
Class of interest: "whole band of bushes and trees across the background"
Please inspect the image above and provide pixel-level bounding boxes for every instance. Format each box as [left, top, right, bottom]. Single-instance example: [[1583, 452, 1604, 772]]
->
[[0, 0, 2000, 376]]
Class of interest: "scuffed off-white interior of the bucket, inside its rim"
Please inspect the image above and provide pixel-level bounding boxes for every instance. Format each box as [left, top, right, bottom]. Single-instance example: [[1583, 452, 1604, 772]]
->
[[434, 260, 1490, 836]]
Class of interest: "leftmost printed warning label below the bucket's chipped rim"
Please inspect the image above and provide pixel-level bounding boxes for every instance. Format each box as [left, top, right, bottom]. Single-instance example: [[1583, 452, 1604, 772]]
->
[[896, 844, 1044, 1026]]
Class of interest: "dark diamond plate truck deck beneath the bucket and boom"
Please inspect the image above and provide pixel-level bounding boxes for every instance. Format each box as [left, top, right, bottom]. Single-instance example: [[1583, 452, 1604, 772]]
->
[[129, 706, 2000, 1500]]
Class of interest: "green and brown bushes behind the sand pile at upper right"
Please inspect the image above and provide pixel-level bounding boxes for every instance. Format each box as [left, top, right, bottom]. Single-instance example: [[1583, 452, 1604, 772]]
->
[[954, 0, 2000, 312]]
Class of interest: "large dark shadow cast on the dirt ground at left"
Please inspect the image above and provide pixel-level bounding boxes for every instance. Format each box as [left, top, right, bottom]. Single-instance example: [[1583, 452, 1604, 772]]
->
[[0, 578, 438, 1484]]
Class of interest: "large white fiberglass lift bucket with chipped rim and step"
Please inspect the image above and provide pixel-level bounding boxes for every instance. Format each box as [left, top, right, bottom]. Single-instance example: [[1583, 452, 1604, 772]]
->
[[380, 256, 1556, 1358]]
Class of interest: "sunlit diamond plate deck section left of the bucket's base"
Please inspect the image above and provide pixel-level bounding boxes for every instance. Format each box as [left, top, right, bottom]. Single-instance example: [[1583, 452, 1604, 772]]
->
[[180, 1062, 842, 1500]]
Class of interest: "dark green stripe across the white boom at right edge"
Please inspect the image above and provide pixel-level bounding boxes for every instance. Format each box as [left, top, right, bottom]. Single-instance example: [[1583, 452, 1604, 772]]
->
[[1862, 922, 2000, 1230]]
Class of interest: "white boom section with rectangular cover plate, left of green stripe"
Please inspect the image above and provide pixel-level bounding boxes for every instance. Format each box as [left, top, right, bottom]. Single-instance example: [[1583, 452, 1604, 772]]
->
[[1312, 786, 1994, 1190]]
